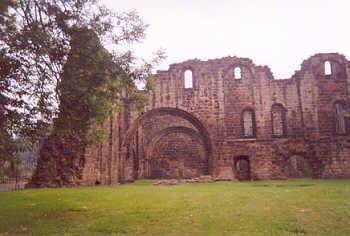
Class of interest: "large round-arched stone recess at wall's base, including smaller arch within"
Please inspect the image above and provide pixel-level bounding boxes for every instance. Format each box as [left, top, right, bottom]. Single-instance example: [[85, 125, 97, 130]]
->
[[119, 108, 212, 181]]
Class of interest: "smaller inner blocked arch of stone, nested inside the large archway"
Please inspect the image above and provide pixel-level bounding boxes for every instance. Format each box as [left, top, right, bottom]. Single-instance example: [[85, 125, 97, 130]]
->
[[144, 126, 209, 178]]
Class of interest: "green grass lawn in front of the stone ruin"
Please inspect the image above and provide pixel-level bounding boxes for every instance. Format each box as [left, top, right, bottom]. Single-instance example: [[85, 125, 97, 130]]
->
[[0, 180, 350, 236]]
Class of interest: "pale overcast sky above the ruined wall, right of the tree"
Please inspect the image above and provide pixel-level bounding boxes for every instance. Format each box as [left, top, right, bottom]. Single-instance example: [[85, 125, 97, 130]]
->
[[102, 0, 350, 79]]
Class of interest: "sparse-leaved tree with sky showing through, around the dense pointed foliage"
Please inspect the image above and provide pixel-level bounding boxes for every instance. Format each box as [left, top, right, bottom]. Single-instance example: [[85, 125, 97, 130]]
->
[[0, 0, 161, 136]]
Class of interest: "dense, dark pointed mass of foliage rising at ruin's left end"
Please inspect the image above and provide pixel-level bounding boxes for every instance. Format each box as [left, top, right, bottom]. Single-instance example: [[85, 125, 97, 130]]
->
[[54, 28, 127, 144]]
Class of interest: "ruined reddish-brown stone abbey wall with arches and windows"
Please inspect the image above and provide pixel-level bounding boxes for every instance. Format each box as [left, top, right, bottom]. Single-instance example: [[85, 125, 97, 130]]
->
[[32, 53, 350, 186]]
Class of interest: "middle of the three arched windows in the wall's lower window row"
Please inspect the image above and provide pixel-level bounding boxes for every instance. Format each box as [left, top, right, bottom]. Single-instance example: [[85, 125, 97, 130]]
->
[[271, 104, 286, 137]]
